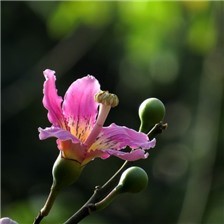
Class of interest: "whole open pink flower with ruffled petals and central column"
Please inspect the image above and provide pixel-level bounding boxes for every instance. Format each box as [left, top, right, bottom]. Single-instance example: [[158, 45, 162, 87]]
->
[[38, 69, 156, 165]]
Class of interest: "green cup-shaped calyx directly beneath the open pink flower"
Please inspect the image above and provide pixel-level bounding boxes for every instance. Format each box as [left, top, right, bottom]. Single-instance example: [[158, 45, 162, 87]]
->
[[52, 154, 83, 189]]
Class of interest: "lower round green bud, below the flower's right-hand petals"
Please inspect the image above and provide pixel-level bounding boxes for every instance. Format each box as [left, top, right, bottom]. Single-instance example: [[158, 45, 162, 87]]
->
[[117, 166, 148, 193]]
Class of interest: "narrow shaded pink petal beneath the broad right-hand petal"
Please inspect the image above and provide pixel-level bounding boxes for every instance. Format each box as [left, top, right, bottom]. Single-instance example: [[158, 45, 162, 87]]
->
[[101, 149, 148, 161]]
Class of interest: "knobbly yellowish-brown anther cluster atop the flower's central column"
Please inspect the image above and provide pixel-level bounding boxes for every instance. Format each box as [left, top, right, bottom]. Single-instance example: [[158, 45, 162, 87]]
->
[[95, 91, 119, 107]]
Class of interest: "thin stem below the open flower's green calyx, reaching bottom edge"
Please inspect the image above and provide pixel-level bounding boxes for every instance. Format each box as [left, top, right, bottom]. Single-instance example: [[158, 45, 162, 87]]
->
[[33, 185, 59, 224]]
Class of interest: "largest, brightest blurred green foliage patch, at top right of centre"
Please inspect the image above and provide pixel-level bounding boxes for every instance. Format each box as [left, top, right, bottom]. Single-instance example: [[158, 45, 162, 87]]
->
[[119, 1, 183, 64]]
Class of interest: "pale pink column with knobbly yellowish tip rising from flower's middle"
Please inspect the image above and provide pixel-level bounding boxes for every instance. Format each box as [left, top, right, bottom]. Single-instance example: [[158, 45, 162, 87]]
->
[[84, 91, 119, 148]]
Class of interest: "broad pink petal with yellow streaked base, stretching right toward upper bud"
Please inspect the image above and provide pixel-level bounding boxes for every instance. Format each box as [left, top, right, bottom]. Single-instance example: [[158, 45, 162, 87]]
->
[[90, 124, 156, 151]]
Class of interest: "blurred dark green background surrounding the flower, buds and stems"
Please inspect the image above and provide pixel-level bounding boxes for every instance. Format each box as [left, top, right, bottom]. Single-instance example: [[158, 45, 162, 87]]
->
[[1, 1, 224, 224]]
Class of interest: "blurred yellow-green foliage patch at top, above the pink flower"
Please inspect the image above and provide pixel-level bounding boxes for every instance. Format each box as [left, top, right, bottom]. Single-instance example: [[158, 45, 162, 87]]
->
[[47, 1, 113, 38]]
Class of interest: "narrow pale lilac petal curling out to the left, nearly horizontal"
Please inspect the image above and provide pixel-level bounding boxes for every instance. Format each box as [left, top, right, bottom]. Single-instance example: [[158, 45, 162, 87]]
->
[[38, 127, 79, 143]]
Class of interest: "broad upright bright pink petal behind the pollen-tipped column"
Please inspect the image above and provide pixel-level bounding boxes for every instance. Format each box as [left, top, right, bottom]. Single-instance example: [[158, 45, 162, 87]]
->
[[62, 75, 100, 142]]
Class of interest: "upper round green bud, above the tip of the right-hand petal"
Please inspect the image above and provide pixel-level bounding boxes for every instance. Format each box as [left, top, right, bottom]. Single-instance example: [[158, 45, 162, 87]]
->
[[138, 98, 166, 133]]
